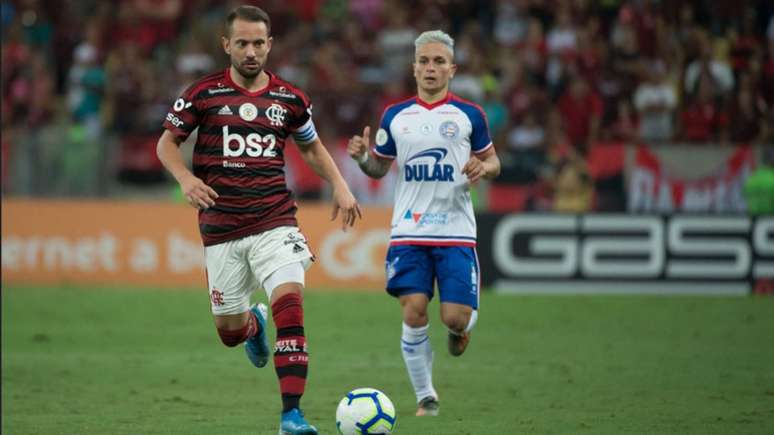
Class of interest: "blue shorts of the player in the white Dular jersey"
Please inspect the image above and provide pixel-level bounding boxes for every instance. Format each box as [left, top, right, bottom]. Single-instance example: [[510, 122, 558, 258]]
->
[[385, 245, 480, 310]]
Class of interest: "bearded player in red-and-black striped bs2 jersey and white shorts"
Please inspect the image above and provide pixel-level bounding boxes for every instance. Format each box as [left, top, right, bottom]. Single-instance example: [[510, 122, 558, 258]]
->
[[157, 6, 361, 434]]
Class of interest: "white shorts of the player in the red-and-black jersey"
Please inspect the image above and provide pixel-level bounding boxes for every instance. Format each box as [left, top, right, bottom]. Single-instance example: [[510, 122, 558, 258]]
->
[[209, 226, 313, 315]]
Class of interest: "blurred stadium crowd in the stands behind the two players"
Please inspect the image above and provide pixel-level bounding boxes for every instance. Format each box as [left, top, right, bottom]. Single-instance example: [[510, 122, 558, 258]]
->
[[2, 0, 774, 211]]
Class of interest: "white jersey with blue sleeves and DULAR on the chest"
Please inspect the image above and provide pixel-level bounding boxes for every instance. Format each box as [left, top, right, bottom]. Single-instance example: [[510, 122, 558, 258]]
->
[[374, 93, 492, 246]]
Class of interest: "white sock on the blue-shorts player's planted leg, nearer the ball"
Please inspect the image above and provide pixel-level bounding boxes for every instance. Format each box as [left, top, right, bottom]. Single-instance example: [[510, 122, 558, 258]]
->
[[400, 323, 438, 402]]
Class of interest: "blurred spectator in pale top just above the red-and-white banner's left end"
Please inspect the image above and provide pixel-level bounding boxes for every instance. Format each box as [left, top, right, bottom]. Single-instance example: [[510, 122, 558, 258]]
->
[[634, 63, 677, 144]]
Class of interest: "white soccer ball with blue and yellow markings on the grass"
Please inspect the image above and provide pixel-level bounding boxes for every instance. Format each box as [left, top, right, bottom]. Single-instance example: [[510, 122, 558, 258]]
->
[[336, 388, 395, 435]]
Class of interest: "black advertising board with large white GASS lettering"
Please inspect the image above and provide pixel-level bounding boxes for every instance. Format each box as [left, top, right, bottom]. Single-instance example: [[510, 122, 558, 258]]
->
[[478, 214, 774, 295]]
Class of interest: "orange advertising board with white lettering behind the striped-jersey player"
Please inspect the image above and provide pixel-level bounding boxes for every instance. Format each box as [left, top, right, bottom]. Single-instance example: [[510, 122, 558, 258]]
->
[[2, 200, 390, 291]]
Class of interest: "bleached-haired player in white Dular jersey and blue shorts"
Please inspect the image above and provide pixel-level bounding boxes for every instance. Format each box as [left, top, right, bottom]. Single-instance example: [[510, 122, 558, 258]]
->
[[347, 30, 500, 416]]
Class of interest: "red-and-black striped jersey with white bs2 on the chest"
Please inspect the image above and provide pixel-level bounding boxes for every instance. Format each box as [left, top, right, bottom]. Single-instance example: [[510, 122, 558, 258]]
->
[[164, 69, 317, 246]]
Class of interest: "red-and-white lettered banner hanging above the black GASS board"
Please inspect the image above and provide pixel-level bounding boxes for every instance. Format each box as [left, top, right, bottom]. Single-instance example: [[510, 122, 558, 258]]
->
[[629, 146, 755, 213]]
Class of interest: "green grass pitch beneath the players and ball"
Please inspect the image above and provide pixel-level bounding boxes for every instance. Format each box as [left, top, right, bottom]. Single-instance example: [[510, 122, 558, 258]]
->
[[2, 287, 774, 435]]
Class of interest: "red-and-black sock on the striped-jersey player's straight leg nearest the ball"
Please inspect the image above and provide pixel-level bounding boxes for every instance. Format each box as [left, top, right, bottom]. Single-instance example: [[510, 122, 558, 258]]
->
[[271, 293, 309, 412]]
